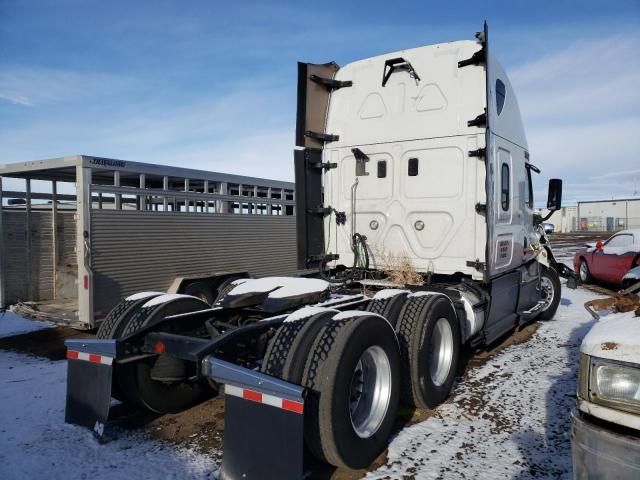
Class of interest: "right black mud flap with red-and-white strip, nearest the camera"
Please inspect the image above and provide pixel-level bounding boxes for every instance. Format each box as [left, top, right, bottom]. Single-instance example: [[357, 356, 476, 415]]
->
[[203, 357, 304, 480]]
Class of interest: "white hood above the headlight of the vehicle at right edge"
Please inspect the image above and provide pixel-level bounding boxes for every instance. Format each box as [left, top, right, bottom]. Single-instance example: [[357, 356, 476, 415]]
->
[[580, 312, 640, 364]]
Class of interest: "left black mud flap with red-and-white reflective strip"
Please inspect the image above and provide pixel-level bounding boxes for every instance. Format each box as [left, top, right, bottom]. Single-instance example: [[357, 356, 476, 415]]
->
[[65, 339, 116, 438]]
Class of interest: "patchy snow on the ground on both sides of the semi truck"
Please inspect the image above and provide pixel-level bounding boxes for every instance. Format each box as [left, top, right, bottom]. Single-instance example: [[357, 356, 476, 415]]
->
[[0, 282, 620, 480]]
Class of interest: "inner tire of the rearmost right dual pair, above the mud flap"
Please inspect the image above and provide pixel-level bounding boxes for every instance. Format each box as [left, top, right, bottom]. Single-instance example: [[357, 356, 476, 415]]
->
[[261, 309, 338, 383]]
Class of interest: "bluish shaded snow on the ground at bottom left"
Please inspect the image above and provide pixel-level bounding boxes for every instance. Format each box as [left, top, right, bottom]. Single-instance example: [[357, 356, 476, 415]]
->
[[0, 351, 217, 480]]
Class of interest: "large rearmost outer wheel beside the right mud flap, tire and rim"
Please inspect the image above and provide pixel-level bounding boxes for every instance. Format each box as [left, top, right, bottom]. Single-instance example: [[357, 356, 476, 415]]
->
[[302, 311, 400, 468]]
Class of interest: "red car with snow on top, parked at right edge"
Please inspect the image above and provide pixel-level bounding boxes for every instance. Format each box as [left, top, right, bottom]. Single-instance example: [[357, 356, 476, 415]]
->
[[573, 229, 640, 284]]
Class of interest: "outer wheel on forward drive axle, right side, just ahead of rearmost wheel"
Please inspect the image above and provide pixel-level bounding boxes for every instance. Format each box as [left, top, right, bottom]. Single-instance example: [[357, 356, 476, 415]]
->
[[396, 294, 460, 408]]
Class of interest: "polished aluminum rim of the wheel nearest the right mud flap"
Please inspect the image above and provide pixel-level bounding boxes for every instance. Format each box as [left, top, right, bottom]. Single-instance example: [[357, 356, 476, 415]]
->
[[349, 346, 391, 438]]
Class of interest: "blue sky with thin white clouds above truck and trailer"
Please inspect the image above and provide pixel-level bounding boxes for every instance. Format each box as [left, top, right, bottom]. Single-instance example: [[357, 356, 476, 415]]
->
[[0, 0, 640, 201]]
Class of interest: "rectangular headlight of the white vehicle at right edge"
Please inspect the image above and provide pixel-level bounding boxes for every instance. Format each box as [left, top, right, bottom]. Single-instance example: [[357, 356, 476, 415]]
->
[[589, 358, 640, 413]]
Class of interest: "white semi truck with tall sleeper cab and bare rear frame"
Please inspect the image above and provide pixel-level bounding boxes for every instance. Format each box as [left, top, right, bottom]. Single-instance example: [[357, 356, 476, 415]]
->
[[66, 25, 575, 479]]
